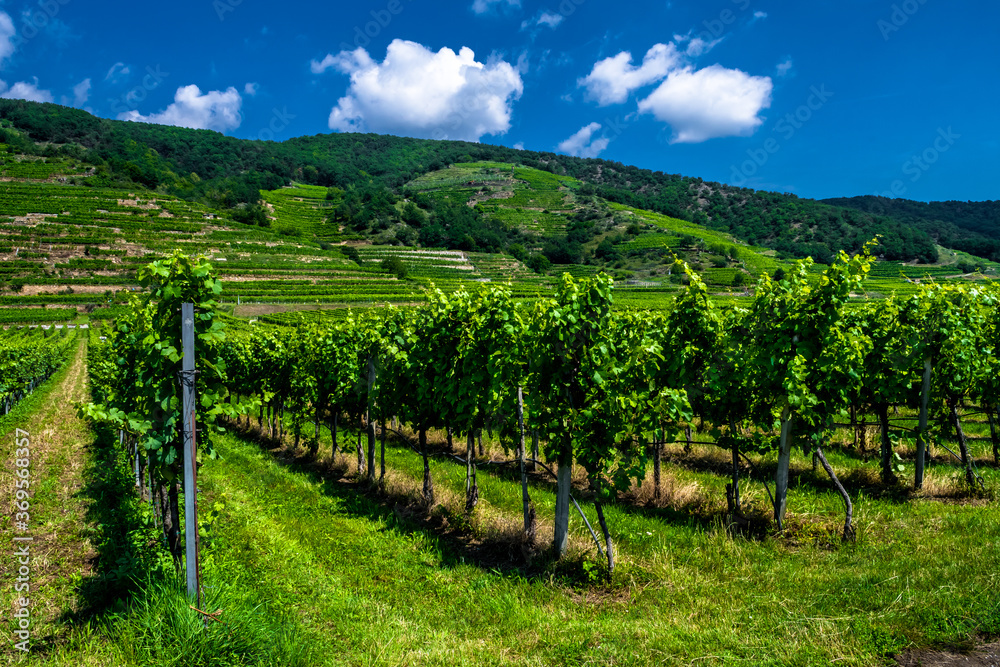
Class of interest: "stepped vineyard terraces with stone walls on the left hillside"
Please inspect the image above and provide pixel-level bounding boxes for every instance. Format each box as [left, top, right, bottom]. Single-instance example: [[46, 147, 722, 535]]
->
[[0, 159, 572, 314]]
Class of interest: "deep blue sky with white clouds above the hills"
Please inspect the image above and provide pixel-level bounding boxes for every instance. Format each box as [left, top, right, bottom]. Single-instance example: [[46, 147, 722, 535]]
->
[[0, 0, 1000, 201]]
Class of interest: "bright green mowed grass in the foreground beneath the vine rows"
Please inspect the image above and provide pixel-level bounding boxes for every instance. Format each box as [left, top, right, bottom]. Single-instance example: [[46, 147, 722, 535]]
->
[[178, 418, 1000, 665]]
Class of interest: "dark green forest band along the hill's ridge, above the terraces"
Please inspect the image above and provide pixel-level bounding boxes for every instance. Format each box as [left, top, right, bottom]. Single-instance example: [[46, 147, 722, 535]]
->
[[0, 100, 976, 263]]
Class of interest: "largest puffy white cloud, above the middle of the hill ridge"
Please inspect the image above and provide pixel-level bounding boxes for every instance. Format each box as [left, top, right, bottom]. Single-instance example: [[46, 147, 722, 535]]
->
[[322, 39, 524, 141]]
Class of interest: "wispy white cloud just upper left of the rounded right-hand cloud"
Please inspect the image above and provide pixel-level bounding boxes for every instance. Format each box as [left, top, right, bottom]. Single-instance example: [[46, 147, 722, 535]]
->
[[577, 44, 680, 106]]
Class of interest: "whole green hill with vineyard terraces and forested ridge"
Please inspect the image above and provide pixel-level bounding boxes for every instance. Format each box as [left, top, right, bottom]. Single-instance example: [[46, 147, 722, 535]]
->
[[0, 100, 1000, 314]]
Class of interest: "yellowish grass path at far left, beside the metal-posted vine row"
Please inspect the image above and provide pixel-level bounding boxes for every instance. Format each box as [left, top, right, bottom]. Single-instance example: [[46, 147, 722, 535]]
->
[[0, 336, 96, 659]]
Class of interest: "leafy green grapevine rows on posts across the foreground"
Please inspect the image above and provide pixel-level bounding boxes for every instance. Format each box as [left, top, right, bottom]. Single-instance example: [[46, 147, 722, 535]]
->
[[87, 247, 1000, 569]]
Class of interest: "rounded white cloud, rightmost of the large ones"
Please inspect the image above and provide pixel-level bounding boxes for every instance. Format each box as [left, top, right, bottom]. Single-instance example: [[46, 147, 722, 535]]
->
[[639, 65, 773, 143]]
